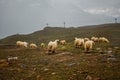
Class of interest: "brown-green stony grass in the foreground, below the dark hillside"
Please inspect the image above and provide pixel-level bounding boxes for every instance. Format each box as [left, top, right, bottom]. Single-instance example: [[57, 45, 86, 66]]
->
[[0, 43, 120, 80]]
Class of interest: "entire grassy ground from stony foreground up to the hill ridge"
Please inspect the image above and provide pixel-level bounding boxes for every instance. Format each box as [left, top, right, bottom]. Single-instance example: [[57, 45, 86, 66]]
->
[[0, 23, 120, 80]]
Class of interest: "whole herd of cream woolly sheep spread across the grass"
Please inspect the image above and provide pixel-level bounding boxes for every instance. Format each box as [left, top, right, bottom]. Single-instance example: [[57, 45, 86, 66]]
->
[[16, 37, 109, 53]]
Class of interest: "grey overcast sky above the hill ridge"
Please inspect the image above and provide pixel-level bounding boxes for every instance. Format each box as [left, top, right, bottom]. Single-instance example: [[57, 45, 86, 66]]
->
[[0, 0, 120, 39]]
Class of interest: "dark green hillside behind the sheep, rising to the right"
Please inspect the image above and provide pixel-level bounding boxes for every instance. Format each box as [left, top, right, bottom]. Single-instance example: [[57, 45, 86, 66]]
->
[[0, 23, 120, 46]]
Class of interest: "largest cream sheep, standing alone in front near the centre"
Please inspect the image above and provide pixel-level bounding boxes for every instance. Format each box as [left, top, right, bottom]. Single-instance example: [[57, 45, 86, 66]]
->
[[48, 39, 59, 53]]
